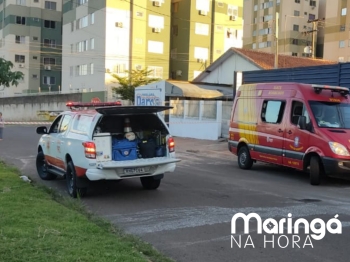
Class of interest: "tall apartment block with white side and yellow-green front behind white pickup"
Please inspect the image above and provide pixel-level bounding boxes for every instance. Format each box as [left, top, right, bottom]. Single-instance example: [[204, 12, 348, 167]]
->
[[62, 0, 171, 92]]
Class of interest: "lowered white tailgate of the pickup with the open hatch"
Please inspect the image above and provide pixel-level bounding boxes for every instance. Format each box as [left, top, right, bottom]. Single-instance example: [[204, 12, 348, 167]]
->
[[96, 157, 181, 169]]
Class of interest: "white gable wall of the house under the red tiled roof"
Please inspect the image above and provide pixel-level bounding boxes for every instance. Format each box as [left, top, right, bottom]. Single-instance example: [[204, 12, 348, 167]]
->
[[197, 54, 260, 85]]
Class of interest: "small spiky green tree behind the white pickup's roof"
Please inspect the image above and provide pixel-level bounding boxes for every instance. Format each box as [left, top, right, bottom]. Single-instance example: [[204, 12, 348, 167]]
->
[[112, 69, 161, 103]]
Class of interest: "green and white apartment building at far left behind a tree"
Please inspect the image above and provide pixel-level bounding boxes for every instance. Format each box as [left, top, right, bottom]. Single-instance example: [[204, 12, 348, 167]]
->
[[0, 0, 62, 97]]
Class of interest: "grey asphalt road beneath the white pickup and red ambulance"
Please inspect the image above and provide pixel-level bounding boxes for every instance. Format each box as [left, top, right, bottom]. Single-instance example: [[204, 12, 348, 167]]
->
[[0, 126, 350, 262]]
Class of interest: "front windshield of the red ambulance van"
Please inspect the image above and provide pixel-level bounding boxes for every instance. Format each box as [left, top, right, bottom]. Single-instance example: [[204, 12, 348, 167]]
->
[[309, 101, 350, 129]]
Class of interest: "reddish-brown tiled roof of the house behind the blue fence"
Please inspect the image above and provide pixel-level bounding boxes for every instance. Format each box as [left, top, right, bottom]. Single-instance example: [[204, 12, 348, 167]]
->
[[231, 48, 338, 69]]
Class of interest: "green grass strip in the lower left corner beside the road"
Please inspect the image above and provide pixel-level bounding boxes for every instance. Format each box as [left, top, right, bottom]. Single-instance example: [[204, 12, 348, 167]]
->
[[0, 162, 172, 262]]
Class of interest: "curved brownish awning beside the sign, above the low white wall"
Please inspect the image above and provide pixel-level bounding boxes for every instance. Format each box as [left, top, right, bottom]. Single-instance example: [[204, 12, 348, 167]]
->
[[165, 81, 224, 99]]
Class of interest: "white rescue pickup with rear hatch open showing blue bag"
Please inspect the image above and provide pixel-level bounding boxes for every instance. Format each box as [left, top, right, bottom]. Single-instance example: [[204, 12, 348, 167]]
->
[[36, 103, 180, 198]]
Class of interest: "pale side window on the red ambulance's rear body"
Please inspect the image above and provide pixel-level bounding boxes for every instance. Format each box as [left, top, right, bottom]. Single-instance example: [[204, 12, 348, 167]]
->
[[261, 100, 286, 124]]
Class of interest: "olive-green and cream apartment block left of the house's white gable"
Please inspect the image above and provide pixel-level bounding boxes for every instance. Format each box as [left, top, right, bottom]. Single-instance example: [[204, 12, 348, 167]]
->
[[170, 0, 243, 80]]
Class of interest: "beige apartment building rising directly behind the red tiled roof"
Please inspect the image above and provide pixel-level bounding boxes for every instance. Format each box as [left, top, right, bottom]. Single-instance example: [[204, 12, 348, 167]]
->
[[243, 0, 323, 58]]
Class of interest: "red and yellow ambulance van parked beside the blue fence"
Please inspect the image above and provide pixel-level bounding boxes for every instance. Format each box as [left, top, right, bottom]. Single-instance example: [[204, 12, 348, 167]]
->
[[228, 83, 350, 185]]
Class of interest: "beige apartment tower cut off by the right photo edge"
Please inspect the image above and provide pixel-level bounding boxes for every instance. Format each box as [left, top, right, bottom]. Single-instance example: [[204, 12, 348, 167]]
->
[[322, 0, 350, 62]]
